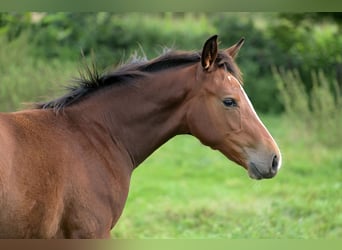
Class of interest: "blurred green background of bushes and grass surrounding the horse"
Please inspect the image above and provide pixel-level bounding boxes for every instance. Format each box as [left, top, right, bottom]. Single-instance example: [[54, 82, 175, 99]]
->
[[0, 12, 342, 238]]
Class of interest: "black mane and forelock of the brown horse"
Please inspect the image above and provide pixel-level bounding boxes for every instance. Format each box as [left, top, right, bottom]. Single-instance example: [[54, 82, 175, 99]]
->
[[35, 51, 242, 111]]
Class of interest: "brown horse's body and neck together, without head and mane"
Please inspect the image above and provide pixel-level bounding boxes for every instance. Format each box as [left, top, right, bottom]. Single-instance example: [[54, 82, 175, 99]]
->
[[0, 64, 194, 238]]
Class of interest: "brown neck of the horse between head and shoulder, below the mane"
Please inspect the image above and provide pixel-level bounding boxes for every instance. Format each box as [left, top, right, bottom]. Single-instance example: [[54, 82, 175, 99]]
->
[[68, 67, 195, 168]]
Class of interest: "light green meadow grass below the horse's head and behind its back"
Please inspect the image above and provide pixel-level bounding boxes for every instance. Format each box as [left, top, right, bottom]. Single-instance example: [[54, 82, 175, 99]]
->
[[0, 34, 342, 239]]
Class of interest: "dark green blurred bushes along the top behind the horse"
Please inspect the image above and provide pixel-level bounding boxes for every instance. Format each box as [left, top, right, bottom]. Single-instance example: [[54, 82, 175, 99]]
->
[[0, 12, 342, 113]]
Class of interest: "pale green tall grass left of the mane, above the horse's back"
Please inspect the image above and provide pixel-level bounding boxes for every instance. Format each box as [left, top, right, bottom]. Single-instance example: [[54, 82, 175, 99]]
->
[[0, 37, 77, 111]]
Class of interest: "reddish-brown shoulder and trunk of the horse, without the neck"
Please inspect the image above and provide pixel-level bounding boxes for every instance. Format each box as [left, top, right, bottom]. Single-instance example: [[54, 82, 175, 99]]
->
[[0, 110, 134, 238]]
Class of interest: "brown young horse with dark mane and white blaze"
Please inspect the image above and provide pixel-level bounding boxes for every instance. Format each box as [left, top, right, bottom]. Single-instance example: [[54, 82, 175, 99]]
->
[[0, 36, 281, 238]]
